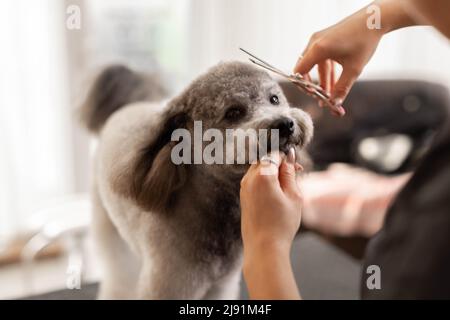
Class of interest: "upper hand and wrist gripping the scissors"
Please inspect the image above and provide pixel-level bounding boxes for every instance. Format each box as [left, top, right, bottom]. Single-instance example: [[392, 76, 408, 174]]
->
[[294, 0, 418, 115]]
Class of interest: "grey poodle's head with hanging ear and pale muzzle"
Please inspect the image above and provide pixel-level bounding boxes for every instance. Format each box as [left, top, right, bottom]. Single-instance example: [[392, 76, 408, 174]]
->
[[117, 62, 313, 210]]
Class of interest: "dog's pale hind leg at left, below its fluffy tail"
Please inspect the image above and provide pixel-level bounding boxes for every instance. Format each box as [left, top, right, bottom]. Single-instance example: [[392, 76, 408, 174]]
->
[[92, 187, 139, 299]]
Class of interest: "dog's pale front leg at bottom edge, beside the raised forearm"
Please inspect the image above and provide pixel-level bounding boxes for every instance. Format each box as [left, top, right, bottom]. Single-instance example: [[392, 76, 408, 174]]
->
[[203, 266, 241, 300]]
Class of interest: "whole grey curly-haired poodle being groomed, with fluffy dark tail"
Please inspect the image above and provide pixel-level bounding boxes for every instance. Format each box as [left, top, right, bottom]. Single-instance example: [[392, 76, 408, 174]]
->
[[84, 62, 313, 299]]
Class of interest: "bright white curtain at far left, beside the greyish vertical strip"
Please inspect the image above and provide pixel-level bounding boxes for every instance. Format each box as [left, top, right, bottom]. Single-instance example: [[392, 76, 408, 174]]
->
[[0, 0, 73, 235]]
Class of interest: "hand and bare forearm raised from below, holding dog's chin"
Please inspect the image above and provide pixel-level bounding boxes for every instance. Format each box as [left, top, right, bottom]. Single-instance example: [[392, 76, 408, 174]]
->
[[241, 150, 303, 299]]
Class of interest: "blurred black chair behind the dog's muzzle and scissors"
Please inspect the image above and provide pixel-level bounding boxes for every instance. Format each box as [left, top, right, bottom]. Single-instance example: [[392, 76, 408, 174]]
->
[[280, 80, 450, 174]]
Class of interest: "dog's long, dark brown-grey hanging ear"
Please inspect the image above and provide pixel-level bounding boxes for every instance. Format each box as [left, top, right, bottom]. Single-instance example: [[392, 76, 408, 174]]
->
[[130, 112, 188, 212]]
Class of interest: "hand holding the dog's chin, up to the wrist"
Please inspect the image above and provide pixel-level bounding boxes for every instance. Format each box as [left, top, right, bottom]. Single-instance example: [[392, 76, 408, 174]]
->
[[240, 154, 303, 250]]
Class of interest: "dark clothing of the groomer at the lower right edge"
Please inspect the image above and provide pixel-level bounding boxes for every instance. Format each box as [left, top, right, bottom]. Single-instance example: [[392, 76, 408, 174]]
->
[[361, 117, 450, 299]]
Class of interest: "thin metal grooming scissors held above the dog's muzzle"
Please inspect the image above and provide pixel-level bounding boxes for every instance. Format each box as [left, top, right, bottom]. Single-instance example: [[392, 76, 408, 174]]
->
[[239, 48, 344, 116]]
